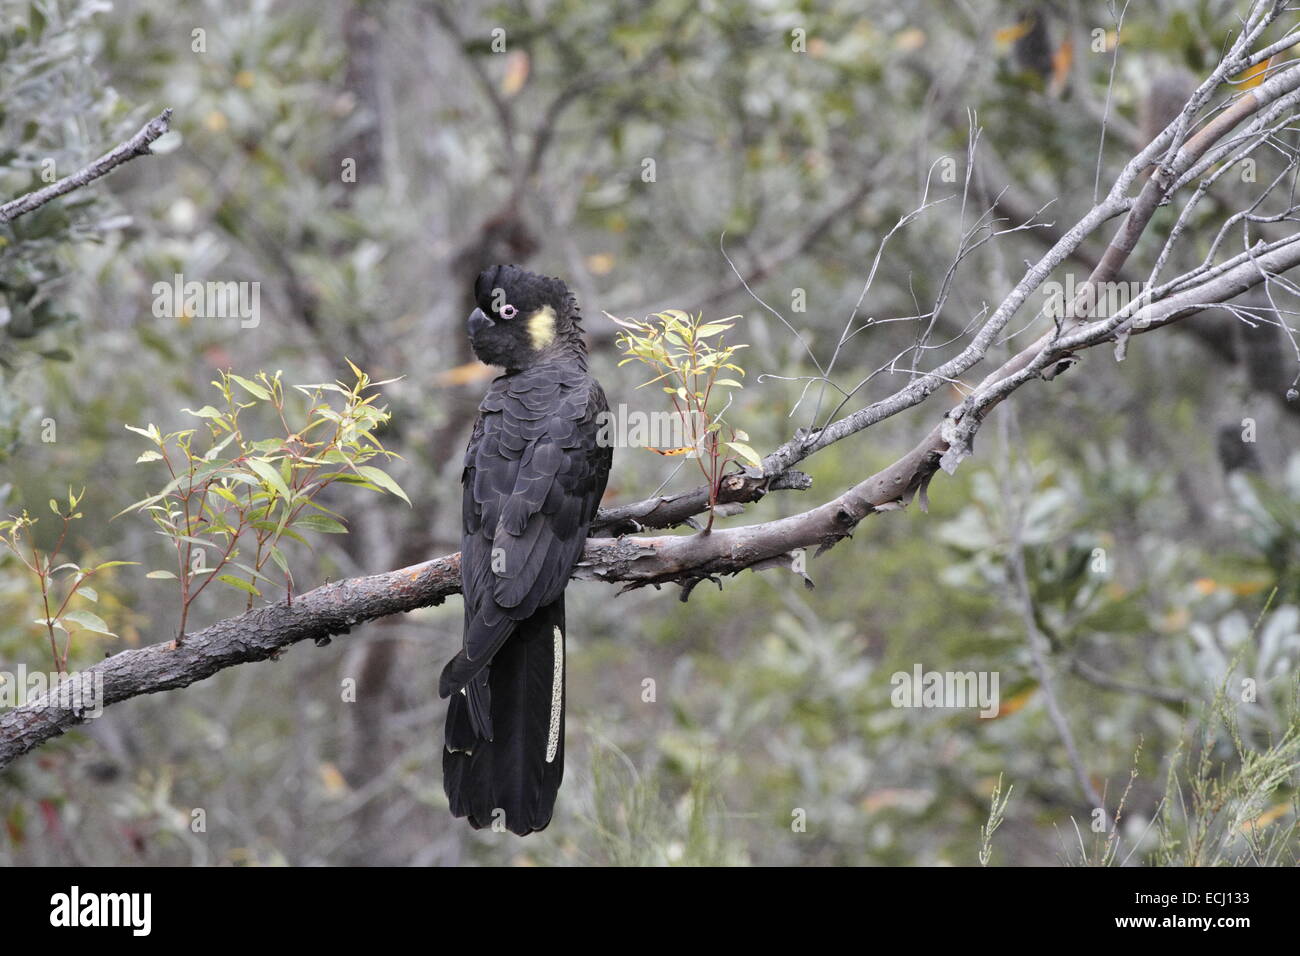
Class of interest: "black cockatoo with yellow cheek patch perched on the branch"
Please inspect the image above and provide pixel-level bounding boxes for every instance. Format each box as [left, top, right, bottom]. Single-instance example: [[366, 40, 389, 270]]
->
[[438, 265, 614, 836]]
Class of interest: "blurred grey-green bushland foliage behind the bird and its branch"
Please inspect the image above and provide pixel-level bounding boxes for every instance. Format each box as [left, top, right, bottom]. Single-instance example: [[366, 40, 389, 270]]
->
[[0, 0, 1300, 865]]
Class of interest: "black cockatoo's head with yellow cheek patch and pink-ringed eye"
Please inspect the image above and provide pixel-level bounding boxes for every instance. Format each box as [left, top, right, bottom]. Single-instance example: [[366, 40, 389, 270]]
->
[[468, 265, 582, 369]]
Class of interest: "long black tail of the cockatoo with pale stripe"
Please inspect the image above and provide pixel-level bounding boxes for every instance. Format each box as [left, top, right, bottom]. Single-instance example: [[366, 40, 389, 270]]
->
[[442, 594, 564, 836]]
